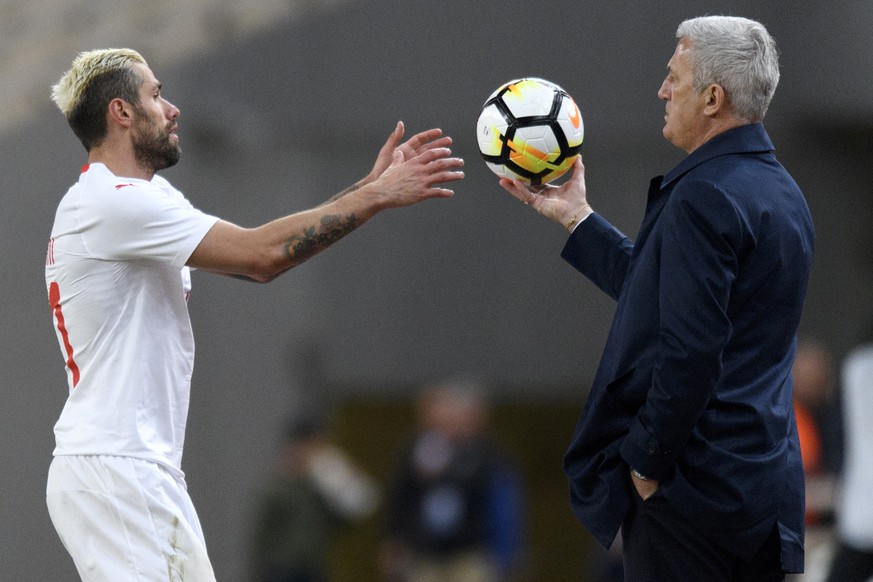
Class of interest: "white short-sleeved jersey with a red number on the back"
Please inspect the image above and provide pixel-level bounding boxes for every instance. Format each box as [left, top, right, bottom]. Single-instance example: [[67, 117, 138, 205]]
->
[[45, 164, 218, 480]]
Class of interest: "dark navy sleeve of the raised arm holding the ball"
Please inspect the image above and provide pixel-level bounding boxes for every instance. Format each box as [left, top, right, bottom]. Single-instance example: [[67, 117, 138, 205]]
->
[[561, 213, 633, 300]]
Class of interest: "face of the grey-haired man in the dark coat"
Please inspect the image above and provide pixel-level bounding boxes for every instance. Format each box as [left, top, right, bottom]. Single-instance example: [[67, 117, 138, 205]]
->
[[658, 39, 707, 153]]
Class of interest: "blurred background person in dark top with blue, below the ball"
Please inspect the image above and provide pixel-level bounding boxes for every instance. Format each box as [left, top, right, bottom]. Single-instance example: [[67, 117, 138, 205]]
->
[[380, 379, 525, 582]]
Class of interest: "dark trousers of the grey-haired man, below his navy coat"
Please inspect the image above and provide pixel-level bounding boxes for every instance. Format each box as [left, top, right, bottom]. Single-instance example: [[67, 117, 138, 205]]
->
[[621, 493, 785, 582]]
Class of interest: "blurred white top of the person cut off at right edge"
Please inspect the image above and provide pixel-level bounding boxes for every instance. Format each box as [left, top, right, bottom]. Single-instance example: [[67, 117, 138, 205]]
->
[[837, 346, 873, 551]]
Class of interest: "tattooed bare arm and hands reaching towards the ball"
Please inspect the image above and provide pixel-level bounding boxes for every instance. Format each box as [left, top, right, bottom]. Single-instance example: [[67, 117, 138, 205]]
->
[[187, 124, 464, 282]]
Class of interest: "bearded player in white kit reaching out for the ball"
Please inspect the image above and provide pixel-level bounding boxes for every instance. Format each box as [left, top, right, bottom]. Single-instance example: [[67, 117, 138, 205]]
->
[[45, 49, 463, 582]]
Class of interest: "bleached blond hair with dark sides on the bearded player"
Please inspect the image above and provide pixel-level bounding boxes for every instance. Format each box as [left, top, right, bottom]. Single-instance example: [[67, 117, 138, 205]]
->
[[51, 48, 148, 151]]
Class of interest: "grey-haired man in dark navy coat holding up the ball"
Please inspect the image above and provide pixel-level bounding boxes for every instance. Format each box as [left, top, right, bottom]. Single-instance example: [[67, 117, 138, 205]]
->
[[501, 16, 814, 582]]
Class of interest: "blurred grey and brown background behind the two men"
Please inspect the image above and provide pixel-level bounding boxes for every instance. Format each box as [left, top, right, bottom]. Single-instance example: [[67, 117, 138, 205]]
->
[[0, 0, 873, 582]]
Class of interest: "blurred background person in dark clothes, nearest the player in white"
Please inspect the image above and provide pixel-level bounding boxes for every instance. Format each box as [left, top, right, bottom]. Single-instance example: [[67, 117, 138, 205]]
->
[[252, 417, 378, 582]]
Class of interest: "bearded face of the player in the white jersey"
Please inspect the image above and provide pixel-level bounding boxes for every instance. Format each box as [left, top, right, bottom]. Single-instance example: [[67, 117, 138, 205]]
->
[[132, 65, 182, 172]]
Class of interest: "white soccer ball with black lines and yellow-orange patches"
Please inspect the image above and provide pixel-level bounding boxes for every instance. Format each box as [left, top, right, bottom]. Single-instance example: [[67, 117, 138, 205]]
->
[[477, 77, 584, 186]]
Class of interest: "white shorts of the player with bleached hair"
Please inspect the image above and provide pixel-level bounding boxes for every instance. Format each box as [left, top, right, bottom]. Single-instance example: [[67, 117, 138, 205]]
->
[[46, 455, 215, 582]]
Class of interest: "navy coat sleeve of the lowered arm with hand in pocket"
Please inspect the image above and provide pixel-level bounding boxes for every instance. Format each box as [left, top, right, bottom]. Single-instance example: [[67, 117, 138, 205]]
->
[[621, 181, 742, 480]]
